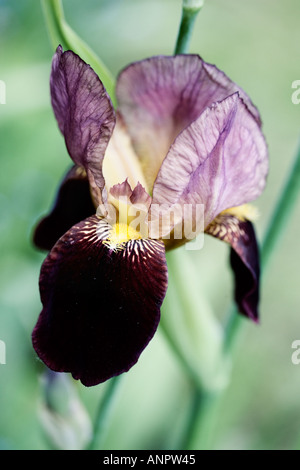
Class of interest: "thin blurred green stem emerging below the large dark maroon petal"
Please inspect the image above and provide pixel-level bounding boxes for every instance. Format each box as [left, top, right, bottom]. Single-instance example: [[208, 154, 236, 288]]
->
[[87, 375, 122, 450]]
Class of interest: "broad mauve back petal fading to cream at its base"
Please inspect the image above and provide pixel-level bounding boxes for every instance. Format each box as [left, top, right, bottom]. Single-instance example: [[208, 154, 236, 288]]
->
[[116, 55, 260, 188]]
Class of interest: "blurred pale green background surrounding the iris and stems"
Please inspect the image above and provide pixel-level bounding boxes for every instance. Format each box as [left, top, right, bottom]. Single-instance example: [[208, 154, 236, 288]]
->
[[0, 0, 300, 450]]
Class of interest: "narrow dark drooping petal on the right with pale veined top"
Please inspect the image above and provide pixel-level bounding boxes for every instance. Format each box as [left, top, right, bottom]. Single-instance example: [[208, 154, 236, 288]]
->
[[205, 211, 260, 322]]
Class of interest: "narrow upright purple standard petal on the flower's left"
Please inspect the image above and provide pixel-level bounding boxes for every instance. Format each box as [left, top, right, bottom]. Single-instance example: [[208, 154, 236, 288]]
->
[[50, 46, 115, 202]]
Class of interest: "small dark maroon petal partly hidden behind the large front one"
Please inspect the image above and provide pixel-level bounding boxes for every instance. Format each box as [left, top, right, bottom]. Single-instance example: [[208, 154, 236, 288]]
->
[[33, 166, 96, 251]]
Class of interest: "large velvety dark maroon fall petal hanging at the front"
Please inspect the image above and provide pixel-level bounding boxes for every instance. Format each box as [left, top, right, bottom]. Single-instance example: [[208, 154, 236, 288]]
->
[[32, 216, 167, 386]]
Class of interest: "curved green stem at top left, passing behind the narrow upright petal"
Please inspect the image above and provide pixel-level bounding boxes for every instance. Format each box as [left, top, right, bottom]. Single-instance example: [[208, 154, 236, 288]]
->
[[42, 0, 116, 106]]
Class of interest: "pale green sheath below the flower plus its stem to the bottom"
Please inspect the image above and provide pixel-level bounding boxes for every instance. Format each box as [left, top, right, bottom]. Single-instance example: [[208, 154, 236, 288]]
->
[[160, 248, 226, 450]]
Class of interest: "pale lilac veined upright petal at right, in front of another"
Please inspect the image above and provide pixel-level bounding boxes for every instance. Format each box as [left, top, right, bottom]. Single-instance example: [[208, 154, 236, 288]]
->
[[152, 93, 268, 232]]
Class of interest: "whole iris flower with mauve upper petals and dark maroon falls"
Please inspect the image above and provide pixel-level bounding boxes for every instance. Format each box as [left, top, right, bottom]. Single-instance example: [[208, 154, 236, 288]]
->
[[32, 46, 268, 386]]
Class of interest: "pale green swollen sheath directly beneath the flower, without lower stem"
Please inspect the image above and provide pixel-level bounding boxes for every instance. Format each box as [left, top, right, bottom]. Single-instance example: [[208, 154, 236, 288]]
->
[[160, 247, 222, 389]]
